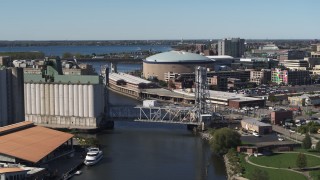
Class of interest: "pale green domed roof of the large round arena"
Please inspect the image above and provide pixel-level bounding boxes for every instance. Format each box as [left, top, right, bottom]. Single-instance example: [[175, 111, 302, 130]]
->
[[145, 51, 212, 63]]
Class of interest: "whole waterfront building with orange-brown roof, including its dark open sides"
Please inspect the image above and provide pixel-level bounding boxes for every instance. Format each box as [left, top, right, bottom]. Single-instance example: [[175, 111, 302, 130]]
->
[[0, 121, 74, 166]]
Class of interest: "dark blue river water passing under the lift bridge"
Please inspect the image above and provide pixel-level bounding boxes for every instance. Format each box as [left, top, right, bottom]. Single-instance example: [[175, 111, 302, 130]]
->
[[73, 92, 226, 180]]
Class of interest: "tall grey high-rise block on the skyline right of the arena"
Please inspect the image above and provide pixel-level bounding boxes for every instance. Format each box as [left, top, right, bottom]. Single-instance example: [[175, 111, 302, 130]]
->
[[218, 38, 245, 57]]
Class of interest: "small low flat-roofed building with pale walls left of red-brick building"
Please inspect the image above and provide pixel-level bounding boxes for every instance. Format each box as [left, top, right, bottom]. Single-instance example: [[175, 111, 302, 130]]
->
[[241, 119, 272, 134]]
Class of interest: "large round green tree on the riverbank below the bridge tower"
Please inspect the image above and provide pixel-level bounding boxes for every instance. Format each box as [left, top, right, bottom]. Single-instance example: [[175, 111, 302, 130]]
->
[[210, 128, 241, 154]]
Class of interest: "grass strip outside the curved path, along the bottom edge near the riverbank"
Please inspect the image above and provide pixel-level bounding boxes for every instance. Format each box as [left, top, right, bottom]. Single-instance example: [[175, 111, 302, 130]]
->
[[240, 154, 307, 180]]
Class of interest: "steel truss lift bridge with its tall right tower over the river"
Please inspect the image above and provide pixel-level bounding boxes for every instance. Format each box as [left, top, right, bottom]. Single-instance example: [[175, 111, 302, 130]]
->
[[109, 67, 211, 125]]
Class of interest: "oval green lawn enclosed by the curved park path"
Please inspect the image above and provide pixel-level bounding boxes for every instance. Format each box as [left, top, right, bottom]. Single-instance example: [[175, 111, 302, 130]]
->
[[249, 153, 320, 168]]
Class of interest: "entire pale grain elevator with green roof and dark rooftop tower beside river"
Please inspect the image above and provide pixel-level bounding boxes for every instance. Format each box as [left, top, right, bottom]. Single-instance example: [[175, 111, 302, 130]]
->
[[24, 58, 107, 129]]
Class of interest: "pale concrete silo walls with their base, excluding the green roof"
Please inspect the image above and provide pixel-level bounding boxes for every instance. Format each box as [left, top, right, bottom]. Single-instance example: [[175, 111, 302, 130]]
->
[[25, 83, 105, 128]]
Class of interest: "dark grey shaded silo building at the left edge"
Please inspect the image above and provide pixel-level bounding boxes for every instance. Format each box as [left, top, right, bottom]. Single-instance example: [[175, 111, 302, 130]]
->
[[0, 67, 24, 127]]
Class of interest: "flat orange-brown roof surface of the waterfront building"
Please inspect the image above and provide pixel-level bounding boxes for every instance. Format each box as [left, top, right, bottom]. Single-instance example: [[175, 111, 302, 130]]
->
[[0, 122, 73, 163]]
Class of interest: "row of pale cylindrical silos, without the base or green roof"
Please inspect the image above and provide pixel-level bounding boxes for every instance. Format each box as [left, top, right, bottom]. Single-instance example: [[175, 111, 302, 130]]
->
[[24, 83, 105, 118]]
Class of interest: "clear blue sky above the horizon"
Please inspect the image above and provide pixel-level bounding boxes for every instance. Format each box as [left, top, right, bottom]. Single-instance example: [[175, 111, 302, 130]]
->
[[0, 0, 320, 40]]
